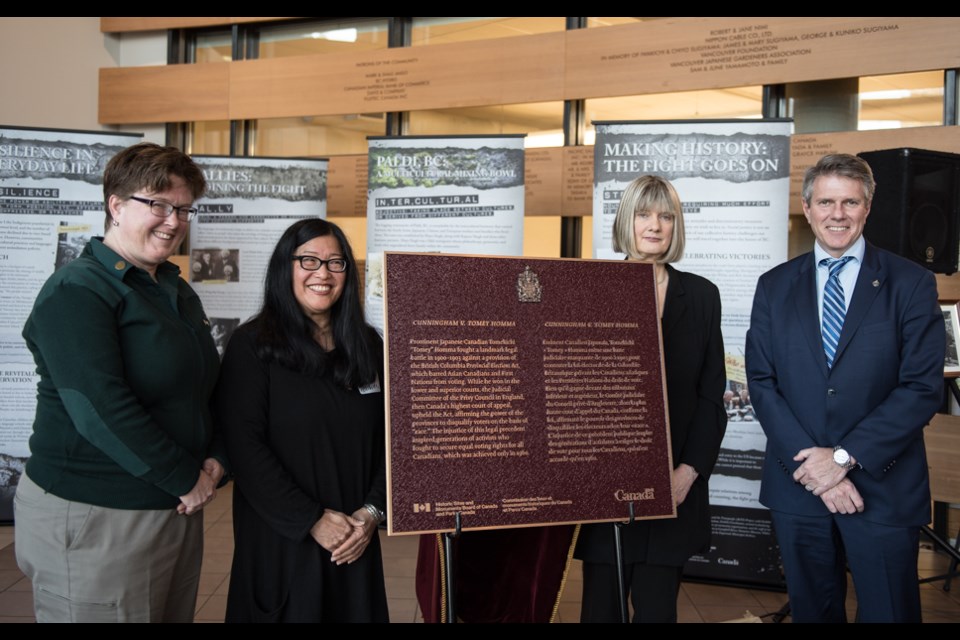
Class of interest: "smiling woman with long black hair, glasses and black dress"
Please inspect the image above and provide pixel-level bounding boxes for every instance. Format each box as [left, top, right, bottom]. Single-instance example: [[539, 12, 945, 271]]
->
[[214, 218, 387, 622]]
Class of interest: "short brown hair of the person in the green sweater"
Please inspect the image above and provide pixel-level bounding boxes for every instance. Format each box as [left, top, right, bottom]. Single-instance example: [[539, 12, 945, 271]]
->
[[103, 142, 207, 228]]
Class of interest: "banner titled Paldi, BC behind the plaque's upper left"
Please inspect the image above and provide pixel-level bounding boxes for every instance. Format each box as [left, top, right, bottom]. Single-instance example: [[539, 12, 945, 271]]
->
[[364, 135, 524, 332]]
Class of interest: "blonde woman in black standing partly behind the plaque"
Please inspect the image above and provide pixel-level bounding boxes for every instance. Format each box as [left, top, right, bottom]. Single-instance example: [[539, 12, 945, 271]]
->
[[575, 176, 727, 622]]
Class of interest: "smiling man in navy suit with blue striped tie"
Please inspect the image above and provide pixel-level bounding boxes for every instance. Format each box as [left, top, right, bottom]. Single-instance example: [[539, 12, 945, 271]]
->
[[746, 155, 945, 622]]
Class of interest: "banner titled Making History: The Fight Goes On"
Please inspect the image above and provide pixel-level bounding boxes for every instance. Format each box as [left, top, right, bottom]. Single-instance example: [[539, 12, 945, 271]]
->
[[593, 120, 793, 584]]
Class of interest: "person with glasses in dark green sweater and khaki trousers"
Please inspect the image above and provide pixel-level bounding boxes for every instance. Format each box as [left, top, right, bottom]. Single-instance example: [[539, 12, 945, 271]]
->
[[14, 143, 225, 622]]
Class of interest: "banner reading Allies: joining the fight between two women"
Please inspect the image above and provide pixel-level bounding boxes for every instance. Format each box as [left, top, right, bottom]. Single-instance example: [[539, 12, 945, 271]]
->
[[183, 156, 328, 355]]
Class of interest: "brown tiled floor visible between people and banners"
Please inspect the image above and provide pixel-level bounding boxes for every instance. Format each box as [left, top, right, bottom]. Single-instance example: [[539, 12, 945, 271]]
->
[[0, 487, 960, 622]]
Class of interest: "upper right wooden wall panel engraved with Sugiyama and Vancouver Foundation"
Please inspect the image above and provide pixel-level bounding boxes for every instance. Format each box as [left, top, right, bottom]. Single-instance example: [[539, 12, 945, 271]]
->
[[565, 18, 960, 99]]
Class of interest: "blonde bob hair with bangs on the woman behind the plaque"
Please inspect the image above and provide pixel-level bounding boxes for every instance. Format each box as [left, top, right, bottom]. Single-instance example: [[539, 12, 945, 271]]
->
[[613, 176, 686, 264]]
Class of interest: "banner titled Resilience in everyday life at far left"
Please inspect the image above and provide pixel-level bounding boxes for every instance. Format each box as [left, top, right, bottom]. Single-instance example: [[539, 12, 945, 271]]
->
[[0, 127, 142, 521]]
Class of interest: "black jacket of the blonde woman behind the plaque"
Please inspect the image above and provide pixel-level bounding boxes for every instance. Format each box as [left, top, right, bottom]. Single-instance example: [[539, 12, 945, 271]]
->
[[575, 265, 727, 566]]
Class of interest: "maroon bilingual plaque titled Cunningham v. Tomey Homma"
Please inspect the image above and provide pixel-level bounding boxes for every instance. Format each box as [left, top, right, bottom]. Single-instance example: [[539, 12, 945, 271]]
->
[[384, 253, 676, 534]]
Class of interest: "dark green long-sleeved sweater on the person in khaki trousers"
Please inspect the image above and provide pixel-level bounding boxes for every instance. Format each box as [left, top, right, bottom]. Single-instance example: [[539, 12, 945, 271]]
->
[[23, 238, 224, 509]]
